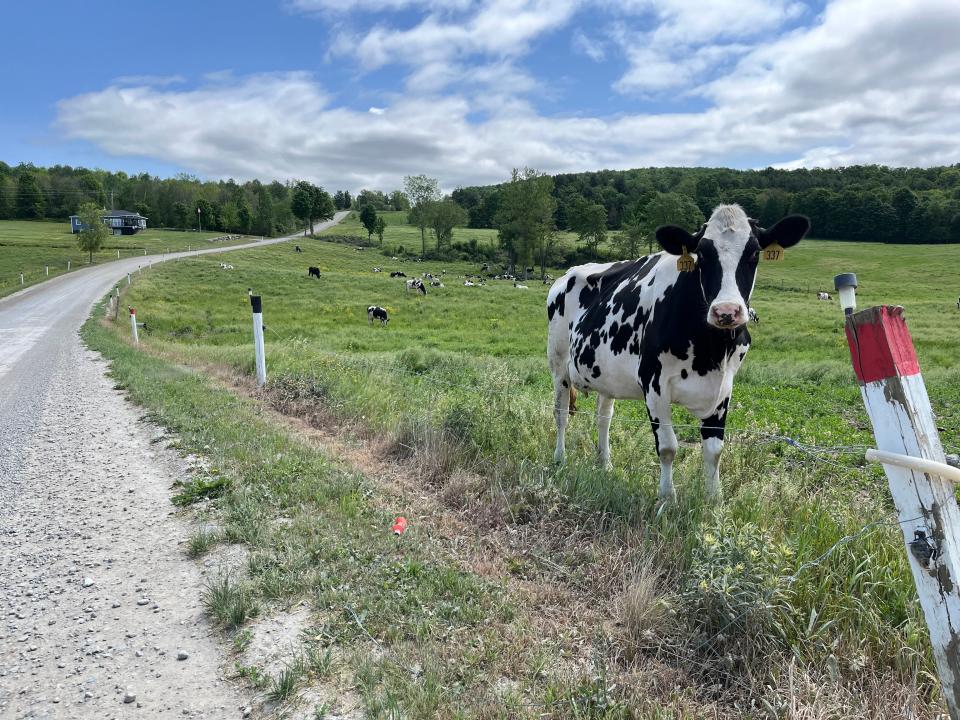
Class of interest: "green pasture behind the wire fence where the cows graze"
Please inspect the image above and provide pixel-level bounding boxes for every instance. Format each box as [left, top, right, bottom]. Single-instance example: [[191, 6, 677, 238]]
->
[[95, 226, 960, 717]]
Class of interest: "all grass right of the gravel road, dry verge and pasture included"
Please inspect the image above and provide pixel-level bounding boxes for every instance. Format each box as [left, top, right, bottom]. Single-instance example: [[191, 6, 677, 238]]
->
[[87, 224, 960, 718]]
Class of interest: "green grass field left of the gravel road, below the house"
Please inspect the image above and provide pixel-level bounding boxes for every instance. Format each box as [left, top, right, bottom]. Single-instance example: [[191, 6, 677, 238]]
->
[[0, 220, 251, 297]]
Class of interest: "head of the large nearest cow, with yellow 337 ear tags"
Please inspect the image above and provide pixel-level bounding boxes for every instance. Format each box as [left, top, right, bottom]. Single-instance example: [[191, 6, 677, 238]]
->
[[657, 205, 810, 329]]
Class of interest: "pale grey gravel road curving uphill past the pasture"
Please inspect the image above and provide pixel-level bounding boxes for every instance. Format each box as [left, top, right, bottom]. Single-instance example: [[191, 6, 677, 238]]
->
[[0, 213, 346, 719]]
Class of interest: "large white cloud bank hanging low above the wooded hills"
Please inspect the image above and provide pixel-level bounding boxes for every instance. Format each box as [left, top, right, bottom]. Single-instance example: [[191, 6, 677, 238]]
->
[[58, 0, 960, 190]]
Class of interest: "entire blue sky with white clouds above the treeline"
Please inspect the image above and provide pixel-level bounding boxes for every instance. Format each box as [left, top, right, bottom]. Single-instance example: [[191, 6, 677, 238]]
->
[[0, 0, 960, 190]]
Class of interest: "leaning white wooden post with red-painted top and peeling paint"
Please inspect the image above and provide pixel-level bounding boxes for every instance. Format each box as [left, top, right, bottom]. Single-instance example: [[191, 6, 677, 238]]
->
[[846, 306, 960, 720]]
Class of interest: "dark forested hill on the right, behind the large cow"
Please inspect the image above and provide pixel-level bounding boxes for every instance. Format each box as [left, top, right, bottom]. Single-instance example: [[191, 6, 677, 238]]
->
[[453, 165, 960, 243]]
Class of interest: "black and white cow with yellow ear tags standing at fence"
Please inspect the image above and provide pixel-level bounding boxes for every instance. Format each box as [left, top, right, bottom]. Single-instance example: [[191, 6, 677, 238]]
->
[[547, 205, 810, 502]]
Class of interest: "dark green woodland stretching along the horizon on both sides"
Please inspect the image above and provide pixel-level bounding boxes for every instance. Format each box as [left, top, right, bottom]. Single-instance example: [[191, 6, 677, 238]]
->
[[0, 162, 960, 243]]
